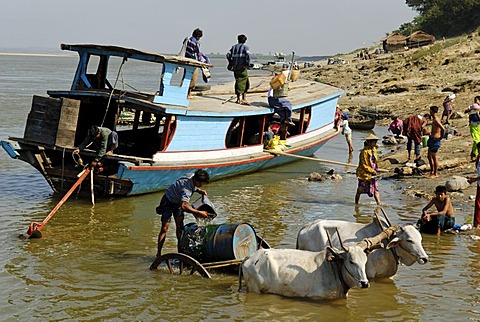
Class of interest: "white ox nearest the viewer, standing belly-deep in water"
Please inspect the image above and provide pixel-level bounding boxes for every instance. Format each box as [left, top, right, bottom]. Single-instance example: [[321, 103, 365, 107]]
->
[[240, 244, 369, 299]]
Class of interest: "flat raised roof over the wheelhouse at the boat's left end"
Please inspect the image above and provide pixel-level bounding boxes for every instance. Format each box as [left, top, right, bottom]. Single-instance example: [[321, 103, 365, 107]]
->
[[60, 44, 212, 67]]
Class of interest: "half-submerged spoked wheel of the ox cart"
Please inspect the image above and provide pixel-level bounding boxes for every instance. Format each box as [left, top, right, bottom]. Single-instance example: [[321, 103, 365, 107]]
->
[[150, 253, 211, 278]]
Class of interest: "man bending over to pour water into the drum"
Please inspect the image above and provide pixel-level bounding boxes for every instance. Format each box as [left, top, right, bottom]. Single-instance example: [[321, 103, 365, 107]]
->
[[150, 170, 210, 269]]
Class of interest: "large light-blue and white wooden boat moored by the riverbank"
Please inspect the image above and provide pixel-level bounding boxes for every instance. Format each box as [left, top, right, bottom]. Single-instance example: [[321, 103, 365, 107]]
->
[[1, 44, 343, 196]]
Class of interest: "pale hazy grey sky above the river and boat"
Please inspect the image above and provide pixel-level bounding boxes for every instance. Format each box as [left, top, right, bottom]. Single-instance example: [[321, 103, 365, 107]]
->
[[0, 0, 415, 55]]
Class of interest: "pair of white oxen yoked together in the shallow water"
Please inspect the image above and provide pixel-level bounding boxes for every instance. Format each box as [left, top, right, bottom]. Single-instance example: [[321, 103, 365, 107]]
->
[[240, 208, 428, 299]]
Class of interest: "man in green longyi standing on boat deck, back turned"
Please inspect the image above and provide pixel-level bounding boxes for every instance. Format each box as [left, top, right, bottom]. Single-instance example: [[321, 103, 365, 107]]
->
[[227, 34, 250, 105]]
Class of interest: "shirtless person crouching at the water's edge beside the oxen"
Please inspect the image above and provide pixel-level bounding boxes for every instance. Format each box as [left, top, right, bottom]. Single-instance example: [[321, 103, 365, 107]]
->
[[419, 186, 455, 235]]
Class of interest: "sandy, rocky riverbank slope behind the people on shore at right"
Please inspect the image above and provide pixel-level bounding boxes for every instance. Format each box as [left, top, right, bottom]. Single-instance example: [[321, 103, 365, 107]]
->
[[302, 33, 480, 211]]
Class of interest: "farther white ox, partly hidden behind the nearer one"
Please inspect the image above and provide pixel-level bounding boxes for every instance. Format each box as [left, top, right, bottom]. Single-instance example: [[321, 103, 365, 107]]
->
[[297, 218, 428, 278]]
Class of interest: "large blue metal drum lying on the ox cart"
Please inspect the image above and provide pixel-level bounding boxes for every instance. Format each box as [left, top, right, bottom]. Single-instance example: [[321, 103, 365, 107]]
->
[[178, 223, 258, 262]]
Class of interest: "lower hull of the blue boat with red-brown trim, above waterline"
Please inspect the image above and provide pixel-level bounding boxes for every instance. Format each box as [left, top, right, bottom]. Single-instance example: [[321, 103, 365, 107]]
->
[[1, 130, 339, 196]]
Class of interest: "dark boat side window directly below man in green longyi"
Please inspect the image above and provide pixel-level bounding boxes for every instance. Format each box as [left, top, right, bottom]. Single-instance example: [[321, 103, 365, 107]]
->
[[225, 115, 265, 148]]
